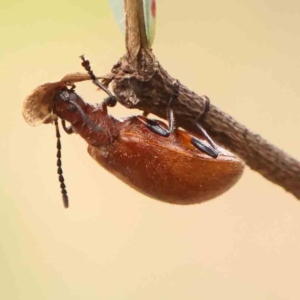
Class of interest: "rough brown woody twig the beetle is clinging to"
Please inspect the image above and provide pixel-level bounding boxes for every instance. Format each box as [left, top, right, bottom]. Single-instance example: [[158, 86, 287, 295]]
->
[[106, 0, 300, 199]]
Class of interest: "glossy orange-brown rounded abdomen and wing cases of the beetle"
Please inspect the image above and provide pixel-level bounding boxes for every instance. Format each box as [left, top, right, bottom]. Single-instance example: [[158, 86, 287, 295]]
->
[[88, 118, 244, 204]]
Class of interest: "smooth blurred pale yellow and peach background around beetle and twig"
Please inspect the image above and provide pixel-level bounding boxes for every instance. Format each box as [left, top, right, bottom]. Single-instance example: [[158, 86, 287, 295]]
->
[[0, 0, 300, 300]]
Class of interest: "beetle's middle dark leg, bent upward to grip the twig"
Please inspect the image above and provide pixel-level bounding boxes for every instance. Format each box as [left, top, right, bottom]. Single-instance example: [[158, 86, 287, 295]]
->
[[143, 80, 179, 137]]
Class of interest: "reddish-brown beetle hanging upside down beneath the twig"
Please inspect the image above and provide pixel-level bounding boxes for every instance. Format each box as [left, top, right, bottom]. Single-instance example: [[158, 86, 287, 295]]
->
[[53, 56, 244, 204]]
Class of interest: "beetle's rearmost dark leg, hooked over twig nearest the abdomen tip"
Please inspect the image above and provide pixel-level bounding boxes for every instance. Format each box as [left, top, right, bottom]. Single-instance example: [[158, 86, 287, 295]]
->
[[191, 96, 219, 158]]
